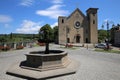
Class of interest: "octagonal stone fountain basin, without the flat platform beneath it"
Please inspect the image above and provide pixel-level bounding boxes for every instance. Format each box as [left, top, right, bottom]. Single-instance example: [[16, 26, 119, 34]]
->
[[20, 50, 70, 71]]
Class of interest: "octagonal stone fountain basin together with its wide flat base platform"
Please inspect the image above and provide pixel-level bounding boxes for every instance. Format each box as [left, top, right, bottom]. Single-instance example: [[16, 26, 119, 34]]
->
[[6, 50, 79, 80]]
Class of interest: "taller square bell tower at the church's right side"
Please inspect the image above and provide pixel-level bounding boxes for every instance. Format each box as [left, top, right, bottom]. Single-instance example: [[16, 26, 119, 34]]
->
[[86, 8, 98, 43]]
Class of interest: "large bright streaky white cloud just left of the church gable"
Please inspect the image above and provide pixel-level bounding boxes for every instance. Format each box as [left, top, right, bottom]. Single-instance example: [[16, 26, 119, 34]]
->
[[36, 5, 68, 19]]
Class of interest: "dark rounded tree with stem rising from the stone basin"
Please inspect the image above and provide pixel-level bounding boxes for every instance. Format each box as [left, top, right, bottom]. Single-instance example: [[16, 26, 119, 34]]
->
[[39, 24, 52, 54]]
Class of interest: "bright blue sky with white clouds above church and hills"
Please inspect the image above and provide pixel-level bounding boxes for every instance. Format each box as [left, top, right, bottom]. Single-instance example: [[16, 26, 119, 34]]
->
[[0, 0, 120, 34]]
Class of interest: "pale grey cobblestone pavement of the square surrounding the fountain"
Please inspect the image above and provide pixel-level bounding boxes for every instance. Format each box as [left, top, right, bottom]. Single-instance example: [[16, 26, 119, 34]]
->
[[0, 44, 120, 80]]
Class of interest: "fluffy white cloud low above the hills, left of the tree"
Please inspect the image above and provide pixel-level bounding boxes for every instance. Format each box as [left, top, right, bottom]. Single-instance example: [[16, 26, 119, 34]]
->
[[16, 20, 41, 33]]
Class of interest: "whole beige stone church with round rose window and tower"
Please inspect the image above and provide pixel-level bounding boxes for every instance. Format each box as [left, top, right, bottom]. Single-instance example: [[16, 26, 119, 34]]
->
[[58, 8, 98, 44]]
